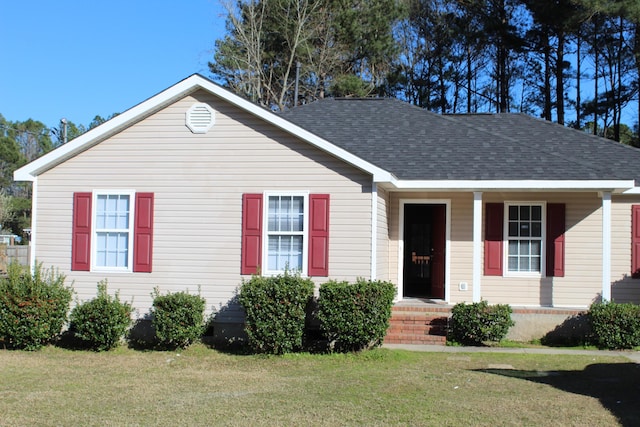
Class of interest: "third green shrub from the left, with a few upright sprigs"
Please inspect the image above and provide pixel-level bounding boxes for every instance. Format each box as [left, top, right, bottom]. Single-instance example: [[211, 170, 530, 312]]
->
[[151, 289, 206, 349]]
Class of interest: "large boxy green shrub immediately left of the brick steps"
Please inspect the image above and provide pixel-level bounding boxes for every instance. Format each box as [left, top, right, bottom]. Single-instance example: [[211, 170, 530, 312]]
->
[[318, 279, 396, 352]]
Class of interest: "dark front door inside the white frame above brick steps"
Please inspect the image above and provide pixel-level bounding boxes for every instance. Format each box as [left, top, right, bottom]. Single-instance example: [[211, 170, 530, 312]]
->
[[403, 204, 446, 299]]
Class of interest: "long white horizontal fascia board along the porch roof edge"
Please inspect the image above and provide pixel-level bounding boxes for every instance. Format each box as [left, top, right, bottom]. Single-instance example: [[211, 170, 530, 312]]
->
[[391, 180, 640, 194]]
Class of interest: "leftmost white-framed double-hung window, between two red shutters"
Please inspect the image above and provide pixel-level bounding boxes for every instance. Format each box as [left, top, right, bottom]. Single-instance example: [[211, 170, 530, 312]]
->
[[93, 192, 134, 271]]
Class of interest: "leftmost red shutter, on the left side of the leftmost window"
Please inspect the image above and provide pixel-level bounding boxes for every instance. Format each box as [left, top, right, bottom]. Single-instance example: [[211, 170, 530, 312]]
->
[[71, 193, 93, 271]]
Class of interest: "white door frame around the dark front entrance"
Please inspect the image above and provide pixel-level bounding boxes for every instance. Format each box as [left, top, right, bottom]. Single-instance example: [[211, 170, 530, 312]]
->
[[396, 199, 451, 303]]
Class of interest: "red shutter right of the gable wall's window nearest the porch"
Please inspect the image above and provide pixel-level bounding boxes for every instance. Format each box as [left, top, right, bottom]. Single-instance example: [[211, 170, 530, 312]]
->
[[309, 194, 329, 277]]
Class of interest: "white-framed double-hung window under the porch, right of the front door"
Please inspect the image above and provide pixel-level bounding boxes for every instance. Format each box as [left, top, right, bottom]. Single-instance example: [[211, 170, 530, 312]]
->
[[506, 204, 544, 274]]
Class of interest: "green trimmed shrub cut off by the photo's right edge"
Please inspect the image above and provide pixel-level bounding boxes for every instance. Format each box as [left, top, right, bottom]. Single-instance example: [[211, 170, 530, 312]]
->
[[587, 302, 640, 349]]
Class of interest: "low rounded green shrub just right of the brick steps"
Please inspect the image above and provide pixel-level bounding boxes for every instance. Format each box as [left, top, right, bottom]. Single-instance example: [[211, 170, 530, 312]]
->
[[447, 301, 514, 345]]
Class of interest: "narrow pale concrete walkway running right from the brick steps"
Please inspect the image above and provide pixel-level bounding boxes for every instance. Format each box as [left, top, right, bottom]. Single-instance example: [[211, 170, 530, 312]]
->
[[382, 344, 640, 363]]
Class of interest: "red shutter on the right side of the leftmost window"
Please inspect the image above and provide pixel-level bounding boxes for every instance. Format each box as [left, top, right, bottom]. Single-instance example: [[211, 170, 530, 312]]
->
[[133, 193, 153, 273]]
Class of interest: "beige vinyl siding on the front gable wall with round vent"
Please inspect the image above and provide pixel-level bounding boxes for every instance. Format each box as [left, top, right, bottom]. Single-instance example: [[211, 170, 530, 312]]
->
[[36, 92, 371, 315]]
